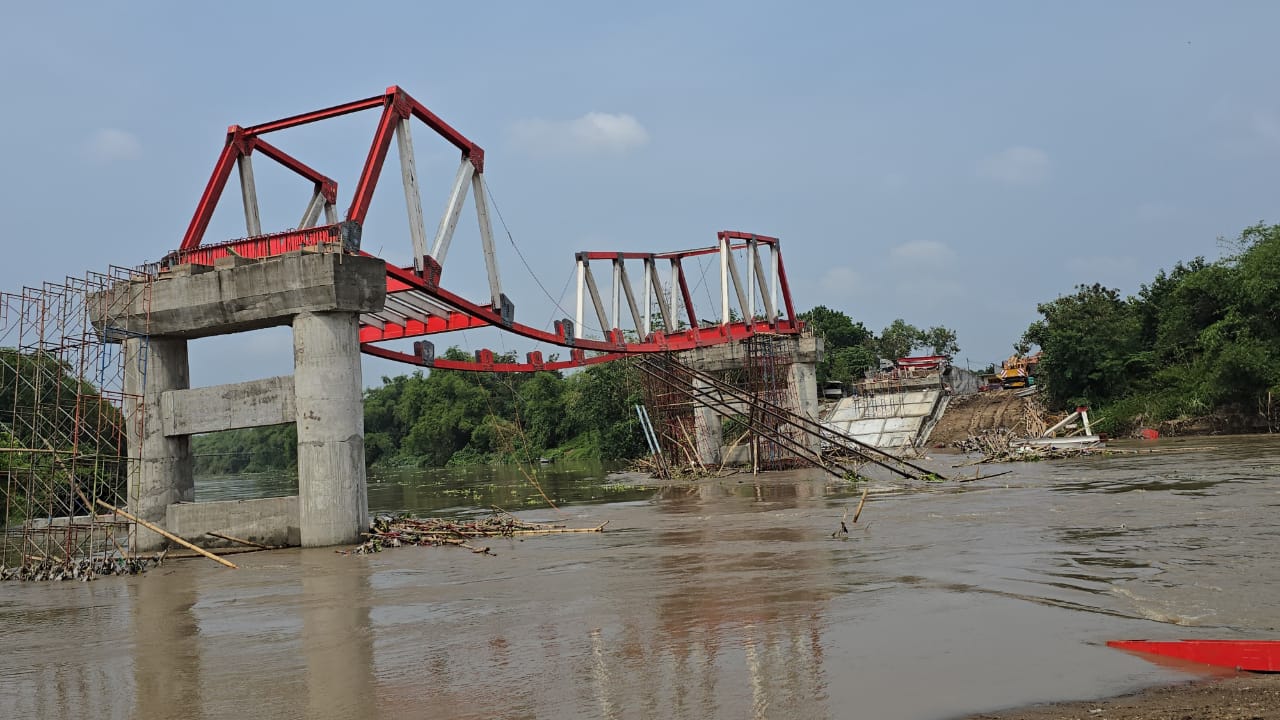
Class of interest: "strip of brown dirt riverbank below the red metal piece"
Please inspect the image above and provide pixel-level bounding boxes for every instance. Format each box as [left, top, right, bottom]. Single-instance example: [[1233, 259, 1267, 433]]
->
[[965, 673, 1280, 720]]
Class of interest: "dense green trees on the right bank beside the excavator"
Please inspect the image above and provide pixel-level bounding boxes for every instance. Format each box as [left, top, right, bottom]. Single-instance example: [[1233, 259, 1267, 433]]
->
[[1021, 223, 1280, 433]]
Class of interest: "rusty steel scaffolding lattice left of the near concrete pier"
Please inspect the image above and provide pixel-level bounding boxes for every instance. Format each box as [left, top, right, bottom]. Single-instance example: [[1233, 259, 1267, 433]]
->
[[0, 266, 151, 579]]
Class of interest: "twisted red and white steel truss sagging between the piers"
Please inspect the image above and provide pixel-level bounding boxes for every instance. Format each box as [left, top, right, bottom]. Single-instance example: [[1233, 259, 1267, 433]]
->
[[161, 86, 800, 372]]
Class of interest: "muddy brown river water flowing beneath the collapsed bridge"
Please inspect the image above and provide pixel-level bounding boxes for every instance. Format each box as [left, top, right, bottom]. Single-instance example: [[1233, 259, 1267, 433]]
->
[[0, 438, 1280, 720]]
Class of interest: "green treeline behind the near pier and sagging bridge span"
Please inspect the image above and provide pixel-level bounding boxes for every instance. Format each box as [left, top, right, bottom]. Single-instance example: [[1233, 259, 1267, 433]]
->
[[193, 347, 644, 474]]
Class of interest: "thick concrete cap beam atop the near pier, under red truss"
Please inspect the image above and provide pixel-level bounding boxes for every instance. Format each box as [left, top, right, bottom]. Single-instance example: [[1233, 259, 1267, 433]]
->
[[90, 251, 387, 338]]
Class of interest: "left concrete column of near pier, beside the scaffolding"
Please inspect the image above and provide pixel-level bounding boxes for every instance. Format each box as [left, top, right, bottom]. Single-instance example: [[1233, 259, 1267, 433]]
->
[[124, 337, 196, 552]]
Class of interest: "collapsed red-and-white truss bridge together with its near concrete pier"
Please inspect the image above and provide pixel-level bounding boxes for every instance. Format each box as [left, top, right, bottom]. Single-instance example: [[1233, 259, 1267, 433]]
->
[[24, 87, 801, 551]]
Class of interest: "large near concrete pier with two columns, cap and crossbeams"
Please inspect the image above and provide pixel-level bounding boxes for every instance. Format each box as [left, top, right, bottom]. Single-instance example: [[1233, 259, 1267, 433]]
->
[[90, 250, 387, 551]]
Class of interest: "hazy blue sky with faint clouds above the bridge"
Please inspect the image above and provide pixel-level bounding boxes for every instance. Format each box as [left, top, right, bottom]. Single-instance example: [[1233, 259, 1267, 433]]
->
[[0, 1, 1280, 384]]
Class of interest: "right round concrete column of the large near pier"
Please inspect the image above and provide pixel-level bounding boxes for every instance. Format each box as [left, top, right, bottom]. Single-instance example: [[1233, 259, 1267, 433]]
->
[[293, 313, 369, 547]]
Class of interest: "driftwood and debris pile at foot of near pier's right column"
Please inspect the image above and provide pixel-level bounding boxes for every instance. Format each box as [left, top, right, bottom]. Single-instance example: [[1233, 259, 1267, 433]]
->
[[346, 511, 608, 555]]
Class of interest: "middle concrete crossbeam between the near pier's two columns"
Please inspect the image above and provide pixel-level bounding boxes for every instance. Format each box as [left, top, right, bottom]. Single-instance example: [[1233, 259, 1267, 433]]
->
[[160, 375, 294, 437]]
